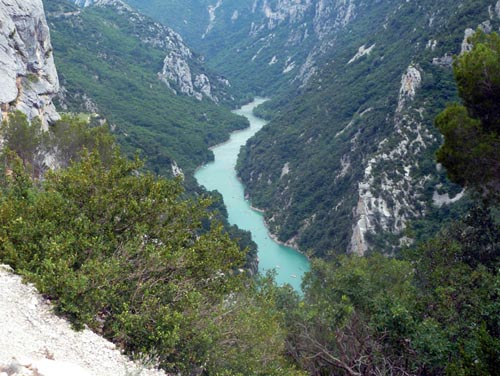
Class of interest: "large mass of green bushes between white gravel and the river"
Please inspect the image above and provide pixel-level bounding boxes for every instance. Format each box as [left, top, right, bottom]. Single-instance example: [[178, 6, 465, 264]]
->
[[0, 118, 300, 376]]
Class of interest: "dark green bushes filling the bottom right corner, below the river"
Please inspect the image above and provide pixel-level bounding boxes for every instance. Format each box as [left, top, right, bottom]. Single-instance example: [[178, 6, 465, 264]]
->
[[276, 214, 500, 375]]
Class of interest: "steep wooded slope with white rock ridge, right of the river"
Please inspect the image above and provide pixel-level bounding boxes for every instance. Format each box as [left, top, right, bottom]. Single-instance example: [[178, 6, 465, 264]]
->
[[239, 0, 500, 255]]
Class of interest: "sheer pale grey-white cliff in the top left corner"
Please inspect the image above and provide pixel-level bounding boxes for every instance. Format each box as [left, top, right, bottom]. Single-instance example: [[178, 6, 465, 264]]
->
[[0, 0, 59, 126]]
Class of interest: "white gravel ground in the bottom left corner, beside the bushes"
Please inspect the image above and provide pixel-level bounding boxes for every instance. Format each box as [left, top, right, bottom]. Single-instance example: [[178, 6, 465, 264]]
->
[[0, 265, 166, 376]]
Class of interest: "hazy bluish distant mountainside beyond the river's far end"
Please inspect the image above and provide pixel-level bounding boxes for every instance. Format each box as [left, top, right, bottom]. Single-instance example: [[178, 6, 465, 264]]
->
[[127, 0, 358, 95]]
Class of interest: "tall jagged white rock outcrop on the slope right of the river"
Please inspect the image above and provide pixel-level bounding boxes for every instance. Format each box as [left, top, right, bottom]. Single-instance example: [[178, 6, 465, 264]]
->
[[349, 65, 435, 255]]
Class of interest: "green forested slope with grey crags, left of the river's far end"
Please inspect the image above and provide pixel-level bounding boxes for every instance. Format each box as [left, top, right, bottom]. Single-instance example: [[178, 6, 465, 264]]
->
[[46, 0, 246, 174]]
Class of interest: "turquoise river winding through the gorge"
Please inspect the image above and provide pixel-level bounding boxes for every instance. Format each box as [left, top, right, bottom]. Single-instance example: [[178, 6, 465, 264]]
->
[[195, 98, 310, 291]]
